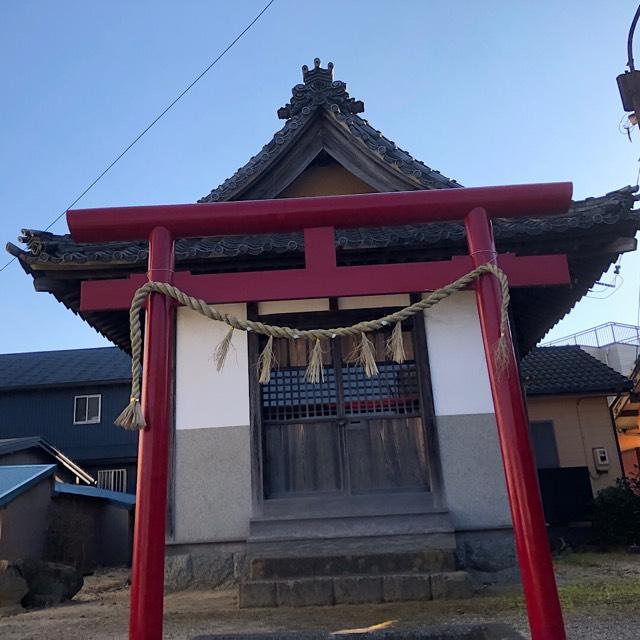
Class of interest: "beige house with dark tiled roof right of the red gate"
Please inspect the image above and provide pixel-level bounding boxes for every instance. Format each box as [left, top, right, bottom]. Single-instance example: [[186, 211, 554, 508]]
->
[[521, 346, 631, 524]]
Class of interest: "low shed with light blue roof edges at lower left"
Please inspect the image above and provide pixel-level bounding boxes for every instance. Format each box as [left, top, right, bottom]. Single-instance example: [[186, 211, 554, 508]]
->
[[0, 464, 135, 570]]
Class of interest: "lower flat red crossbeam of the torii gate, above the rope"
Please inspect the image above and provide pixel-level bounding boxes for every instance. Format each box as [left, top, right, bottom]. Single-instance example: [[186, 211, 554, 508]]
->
[[80, 248, 571, 311]]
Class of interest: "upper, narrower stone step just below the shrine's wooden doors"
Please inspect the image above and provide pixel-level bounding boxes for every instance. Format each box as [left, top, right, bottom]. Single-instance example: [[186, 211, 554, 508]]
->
[[249, 549, 455, 580]]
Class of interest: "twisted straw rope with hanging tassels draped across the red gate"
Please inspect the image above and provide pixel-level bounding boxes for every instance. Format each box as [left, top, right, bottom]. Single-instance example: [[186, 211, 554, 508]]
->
[[115, 263, 509, 429]]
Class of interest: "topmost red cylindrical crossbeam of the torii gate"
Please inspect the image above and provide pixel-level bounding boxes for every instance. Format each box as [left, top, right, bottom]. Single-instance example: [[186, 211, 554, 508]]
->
[[67, 182, 573, 242]]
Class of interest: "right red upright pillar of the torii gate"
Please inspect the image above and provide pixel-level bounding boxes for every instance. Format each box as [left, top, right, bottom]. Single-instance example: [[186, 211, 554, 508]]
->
[[465, 208, 566, 640]]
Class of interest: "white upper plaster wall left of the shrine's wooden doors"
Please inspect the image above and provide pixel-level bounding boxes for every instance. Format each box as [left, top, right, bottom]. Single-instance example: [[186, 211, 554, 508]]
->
[[176, 304, 249, 429]]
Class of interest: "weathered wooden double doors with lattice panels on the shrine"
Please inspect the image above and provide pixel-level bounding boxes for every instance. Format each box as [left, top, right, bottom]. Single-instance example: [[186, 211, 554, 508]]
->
[[261, 322, 428, 498]]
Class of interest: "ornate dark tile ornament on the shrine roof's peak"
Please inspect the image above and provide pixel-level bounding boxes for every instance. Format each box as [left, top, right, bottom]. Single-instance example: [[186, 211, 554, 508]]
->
[[278, 58, 364, 120]]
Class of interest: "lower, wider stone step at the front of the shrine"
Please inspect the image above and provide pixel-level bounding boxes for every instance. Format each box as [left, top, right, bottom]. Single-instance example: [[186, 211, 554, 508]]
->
[[240, 571, 473, 609]]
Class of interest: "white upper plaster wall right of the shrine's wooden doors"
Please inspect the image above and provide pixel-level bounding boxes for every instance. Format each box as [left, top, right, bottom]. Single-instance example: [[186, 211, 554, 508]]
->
[[425, 291, 494, 416]]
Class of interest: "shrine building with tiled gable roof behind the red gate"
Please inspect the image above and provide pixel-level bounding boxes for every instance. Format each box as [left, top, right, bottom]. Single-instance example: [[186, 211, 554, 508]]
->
[[9, 61, 640, 592]]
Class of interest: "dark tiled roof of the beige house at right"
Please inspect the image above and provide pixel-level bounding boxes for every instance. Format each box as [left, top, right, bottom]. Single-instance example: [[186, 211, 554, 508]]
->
[[520, 345, 631, 396]]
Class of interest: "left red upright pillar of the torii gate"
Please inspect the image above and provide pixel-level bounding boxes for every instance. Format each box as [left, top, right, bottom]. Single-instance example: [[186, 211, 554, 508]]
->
[[129, 227, 174, 640]]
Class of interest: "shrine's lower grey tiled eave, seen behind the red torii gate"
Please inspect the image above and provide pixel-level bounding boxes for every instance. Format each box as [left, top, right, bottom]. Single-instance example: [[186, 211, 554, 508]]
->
[[11, 187, 640, 269]]
